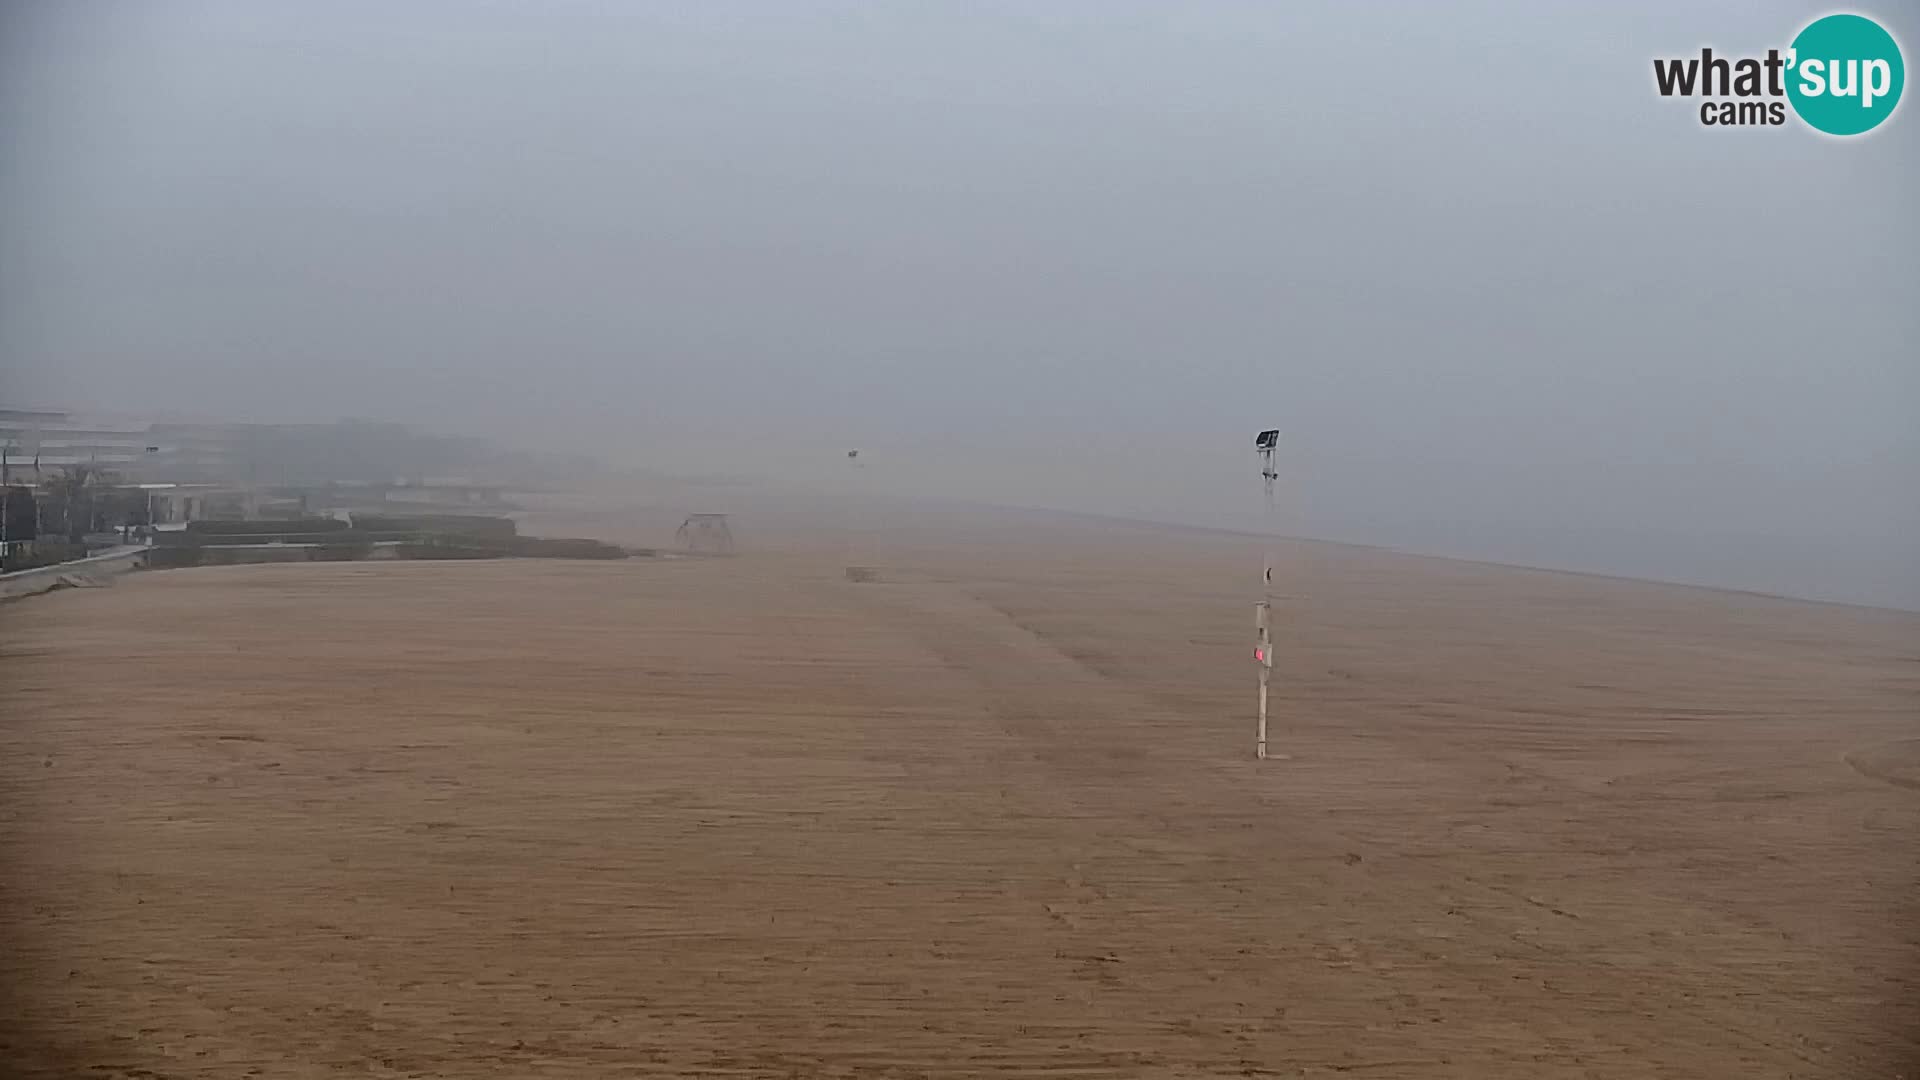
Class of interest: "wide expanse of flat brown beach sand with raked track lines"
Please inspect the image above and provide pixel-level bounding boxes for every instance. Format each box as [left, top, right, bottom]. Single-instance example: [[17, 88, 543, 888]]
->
[[0, 511, 1920, 1078]]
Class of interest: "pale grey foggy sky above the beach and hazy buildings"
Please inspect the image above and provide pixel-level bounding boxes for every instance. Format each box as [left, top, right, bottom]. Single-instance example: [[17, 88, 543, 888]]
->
[[0, 0, 1920, 607]]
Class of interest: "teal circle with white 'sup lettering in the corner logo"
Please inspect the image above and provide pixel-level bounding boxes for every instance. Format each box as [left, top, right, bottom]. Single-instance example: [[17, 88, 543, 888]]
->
[[1788, 15, 1907, 135]]
